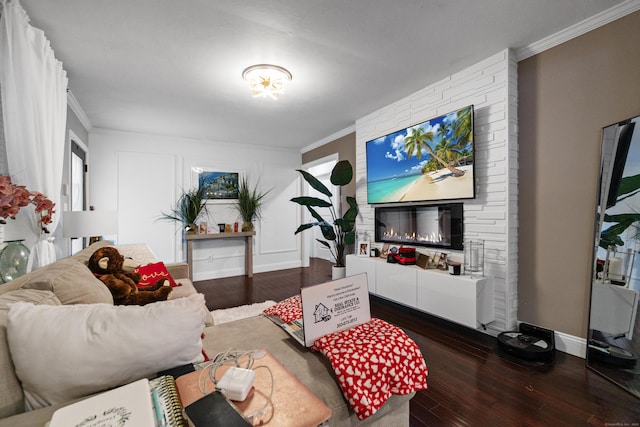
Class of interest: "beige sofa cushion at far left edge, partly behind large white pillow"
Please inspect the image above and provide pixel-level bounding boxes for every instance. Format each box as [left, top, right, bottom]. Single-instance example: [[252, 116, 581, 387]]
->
[[0, 289, 60, 418]]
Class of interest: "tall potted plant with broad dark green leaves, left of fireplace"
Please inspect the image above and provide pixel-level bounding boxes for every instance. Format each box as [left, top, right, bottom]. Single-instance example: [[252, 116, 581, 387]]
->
[[291, 160, 358, 279]]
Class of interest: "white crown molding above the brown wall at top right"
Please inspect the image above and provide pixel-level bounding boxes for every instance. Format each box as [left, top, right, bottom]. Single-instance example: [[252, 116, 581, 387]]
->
[[515, 0, 640, 62]]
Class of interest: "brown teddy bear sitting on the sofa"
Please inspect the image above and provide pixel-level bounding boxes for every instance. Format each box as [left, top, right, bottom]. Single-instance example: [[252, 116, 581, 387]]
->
[[87, 246, 171, 305]]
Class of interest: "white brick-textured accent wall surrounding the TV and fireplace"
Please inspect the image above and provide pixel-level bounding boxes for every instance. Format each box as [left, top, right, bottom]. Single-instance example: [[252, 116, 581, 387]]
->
[[356, 50, 518, 333]]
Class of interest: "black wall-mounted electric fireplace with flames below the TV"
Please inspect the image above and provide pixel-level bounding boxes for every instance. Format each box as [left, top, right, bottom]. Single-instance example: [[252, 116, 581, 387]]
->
[[375, 203, 464, 250]]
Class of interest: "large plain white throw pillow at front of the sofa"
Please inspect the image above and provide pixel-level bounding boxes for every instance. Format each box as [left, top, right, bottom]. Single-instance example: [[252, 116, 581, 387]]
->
[[7, 294, 206, 410]]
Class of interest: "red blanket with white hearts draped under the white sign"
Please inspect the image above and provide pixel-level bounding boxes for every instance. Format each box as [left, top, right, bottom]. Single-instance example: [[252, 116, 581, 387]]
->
[[265, 295, 429, 420]]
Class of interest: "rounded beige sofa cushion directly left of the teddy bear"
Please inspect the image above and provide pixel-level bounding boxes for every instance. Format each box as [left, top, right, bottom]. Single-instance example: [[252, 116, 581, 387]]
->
[[22, 258, 113, 304]]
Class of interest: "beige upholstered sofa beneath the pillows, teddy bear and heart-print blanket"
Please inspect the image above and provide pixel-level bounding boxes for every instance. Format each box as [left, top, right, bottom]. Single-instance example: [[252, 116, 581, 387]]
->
[[0, 242, 413, 427]]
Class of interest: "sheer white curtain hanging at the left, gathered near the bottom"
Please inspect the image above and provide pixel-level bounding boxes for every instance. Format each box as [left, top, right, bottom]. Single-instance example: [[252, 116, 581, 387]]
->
[[0, 0, 68, 269]]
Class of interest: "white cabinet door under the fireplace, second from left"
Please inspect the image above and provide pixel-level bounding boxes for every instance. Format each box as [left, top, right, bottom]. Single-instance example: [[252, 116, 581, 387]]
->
[[375, 262, 417, 307]]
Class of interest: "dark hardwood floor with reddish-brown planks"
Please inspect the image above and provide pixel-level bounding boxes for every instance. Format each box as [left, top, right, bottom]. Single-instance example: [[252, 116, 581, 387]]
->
[[195, 260, 640, 427]]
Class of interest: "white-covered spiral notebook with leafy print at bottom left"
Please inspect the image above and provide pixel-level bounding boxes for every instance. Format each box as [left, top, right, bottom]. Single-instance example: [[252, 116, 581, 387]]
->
[[48, 375, 188, 427]]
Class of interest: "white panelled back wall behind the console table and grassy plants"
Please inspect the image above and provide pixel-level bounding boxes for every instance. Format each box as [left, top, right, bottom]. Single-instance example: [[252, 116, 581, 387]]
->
[[88, 129, 301, 280]]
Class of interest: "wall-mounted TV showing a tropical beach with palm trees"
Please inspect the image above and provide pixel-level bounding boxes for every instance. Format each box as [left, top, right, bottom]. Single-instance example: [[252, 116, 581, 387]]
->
[[366, 106, 474, 203]]
